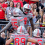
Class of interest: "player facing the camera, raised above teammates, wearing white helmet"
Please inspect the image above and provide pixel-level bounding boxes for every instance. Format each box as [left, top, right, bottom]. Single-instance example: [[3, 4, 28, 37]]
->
[[21, 4, 34, 34]]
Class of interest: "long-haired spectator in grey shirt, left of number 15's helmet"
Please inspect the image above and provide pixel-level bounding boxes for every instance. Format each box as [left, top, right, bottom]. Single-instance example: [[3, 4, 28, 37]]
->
[[5, 1, 14, 20]]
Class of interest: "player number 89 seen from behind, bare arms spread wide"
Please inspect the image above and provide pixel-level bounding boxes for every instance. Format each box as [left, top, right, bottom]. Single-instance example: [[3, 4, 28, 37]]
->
[[6, 26, 38, 45]]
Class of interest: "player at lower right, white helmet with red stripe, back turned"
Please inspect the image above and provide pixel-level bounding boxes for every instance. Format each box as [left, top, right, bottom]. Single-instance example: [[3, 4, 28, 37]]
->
[[30, 29, 44, 45]]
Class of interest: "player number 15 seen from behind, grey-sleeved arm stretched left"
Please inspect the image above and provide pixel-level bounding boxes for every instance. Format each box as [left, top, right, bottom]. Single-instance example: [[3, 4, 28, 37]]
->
[[0, 8, 24, 33]]
